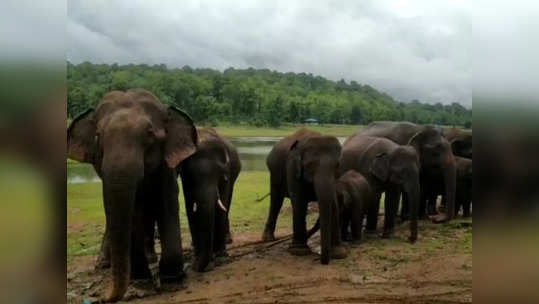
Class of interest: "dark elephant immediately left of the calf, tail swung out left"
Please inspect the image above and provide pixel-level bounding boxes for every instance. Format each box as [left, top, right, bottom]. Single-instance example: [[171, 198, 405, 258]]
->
[[262, 129, 346, 264]]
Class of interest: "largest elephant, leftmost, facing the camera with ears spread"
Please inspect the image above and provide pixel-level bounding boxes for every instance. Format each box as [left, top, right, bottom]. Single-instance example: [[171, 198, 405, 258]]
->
[[67, 89, 197, 302]]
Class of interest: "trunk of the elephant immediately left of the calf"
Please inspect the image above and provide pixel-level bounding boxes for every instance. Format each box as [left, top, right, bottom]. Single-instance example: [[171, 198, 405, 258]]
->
[[314, 174, 336, 264]]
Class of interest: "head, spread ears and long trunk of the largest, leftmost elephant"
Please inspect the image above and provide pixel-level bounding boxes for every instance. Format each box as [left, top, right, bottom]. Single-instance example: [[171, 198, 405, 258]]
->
[[67, 89, 197, 301]]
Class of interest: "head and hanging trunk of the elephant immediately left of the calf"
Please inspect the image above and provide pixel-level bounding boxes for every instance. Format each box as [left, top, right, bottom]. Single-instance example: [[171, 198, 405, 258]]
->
[[289, 136, 341, 264]]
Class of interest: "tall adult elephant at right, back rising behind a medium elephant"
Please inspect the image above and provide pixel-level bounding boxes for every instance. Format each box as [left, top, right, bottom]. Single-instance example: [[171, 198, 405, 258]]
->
[[357, 121, 456, 223]]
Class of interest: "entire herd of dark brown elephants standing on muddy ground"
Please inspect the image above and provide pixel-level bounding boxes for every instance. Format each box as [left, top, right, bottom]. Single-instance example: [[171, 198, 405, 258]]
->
[[67, 89, 472, 302]]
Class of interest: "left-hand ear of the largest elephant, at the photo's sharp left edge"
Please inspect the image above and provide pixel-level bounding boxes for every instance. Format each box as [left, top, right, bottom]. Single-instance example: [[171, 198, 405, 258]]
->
[[67, 109, 97, 163]]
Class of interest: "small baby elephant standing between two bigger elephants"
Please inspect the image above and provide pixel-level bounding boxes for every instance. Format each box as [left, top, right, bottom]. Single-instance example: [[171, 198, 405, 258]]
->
[[307, 170, 372, 242]]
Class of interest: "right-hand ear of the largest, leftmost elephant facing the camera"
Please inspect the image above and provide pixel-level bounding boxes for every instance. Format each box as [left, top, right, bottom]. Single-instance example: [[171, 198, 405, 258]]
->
[[164, 106, 198, 168]]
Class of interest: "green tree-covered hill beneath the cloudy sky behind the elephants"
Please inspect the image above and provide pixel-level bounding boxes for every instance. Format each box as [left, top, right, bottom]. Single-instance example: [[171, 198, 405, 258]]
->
[[67, 62, 472, 126]]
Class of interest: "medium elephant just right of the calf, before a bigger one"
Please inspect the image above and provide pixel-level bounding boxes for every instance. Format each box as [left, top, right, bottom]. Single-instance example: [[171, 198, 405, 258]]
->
[[339, 135, 420, 243]]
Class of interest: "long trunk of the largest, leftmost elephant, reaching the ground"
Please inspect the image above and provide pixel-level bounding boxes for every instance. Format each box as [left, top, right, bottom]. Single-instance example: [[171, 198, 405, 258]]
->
[[103, 158, 144, 301]]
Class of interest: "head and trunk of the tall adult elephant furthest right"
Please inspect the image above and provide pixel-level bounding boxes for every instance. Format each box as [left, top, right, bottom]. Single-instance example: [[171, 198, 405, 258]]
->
[[408, 126, 456, 222]]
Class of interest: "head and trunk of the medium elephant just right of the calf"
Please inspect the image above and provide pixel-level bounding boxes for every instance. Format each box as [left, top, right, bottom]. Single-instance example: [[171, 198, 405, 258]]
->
[[369, 146, 421, 242]]
